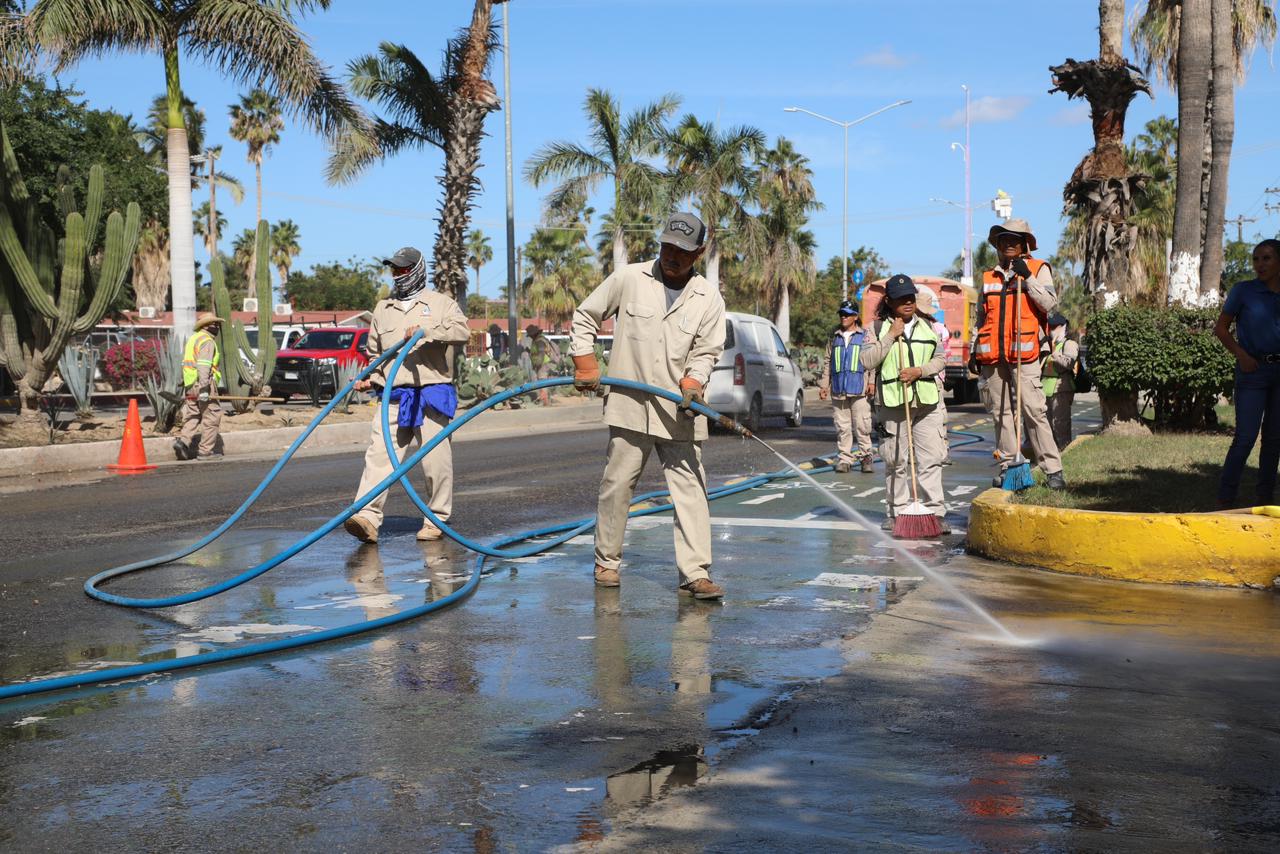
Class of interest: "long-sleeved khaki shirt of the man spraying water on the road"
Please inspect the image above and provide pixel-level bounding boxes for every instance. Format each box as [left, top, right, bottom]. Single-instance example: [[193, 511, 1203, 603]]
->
[[570, 261, 724, 442]]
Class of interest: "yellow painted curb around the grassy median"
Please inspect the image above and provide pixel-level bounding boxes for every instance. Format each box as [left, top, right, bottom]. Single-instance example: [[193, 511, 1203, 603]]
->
[[969, 489, 1280, 588]]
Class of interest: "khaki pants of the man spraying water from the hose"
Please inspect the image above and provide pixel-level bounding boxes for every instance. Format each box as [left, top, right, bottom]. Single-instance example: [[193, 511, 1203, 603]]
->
[[595, 426, 712, 584]]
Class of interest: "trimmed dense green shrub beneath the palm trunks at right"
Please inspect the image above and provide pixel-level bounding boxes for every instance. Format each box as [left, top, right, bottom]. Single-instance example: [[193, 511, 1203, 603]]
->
[[1087, 305, 1235, 429]]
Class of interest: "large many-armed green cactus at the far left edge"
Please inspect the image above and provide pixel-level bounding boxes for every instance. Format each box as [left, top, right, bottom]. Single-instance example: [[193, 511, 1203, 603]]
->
[[0, 123, 142, 419]]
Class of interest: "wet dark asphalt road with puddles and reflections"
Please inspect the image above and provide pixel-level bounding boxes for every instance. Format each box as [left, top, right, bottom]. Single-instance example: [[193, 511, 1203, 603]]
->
[[0, 396, 1280, 851]]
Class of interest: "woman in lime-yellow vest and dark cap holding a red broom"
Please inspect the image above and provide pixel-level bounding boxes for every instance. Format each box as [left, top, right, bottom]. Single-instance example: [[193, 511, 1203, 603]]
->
[[861, 274, 951, 539]]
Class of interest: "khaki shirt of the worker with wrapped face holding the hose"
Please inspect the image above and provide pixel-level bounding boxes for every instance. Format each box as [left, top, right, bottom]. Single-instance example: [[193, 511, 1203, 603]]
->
[[365, 288, 471, 385]]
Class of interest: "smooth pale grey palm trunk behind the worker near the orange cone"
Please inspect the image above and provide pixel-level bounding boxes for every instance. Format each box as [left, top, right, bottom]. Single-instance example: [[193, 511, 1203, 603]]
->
[[164, 45, 196, 341]]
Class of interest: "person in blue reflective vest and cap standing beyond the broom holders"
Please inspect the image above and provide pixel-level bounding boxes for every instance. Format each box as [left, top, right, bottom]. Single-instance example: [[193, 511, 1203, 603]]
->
[[818, 300, 876, 474]]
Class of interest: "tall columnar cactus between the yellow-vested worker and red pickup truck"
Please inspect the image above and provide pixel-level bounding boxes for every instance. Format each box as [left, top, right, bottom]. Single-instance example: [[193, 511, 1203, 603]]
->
[[209, 219, 275, 412]]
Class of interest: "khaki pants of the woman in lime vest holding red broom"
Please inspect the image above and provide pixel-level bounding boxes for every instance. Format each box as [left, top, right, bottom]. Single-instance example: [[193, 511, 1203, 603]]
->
[[879, 406, 947, 516]]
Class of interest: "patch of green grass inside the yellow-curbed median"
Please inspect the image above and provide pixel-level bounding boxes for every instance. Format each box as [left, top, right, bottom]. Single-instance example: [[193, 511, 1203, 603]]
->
[[1015, 407, 1258, 513]]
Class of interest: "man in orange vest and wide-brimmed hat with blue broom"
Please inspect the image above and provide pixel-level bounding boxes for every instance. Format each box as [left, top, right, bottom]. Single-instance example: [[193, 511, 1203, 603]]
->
[[970, 219, 1066, 489]]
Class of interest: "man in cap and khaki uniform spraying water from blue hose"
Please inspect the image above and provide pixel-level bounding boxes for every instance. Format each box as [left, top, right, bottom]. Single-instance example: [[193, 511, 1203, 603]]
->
[[570, 214, 724, 599]]
